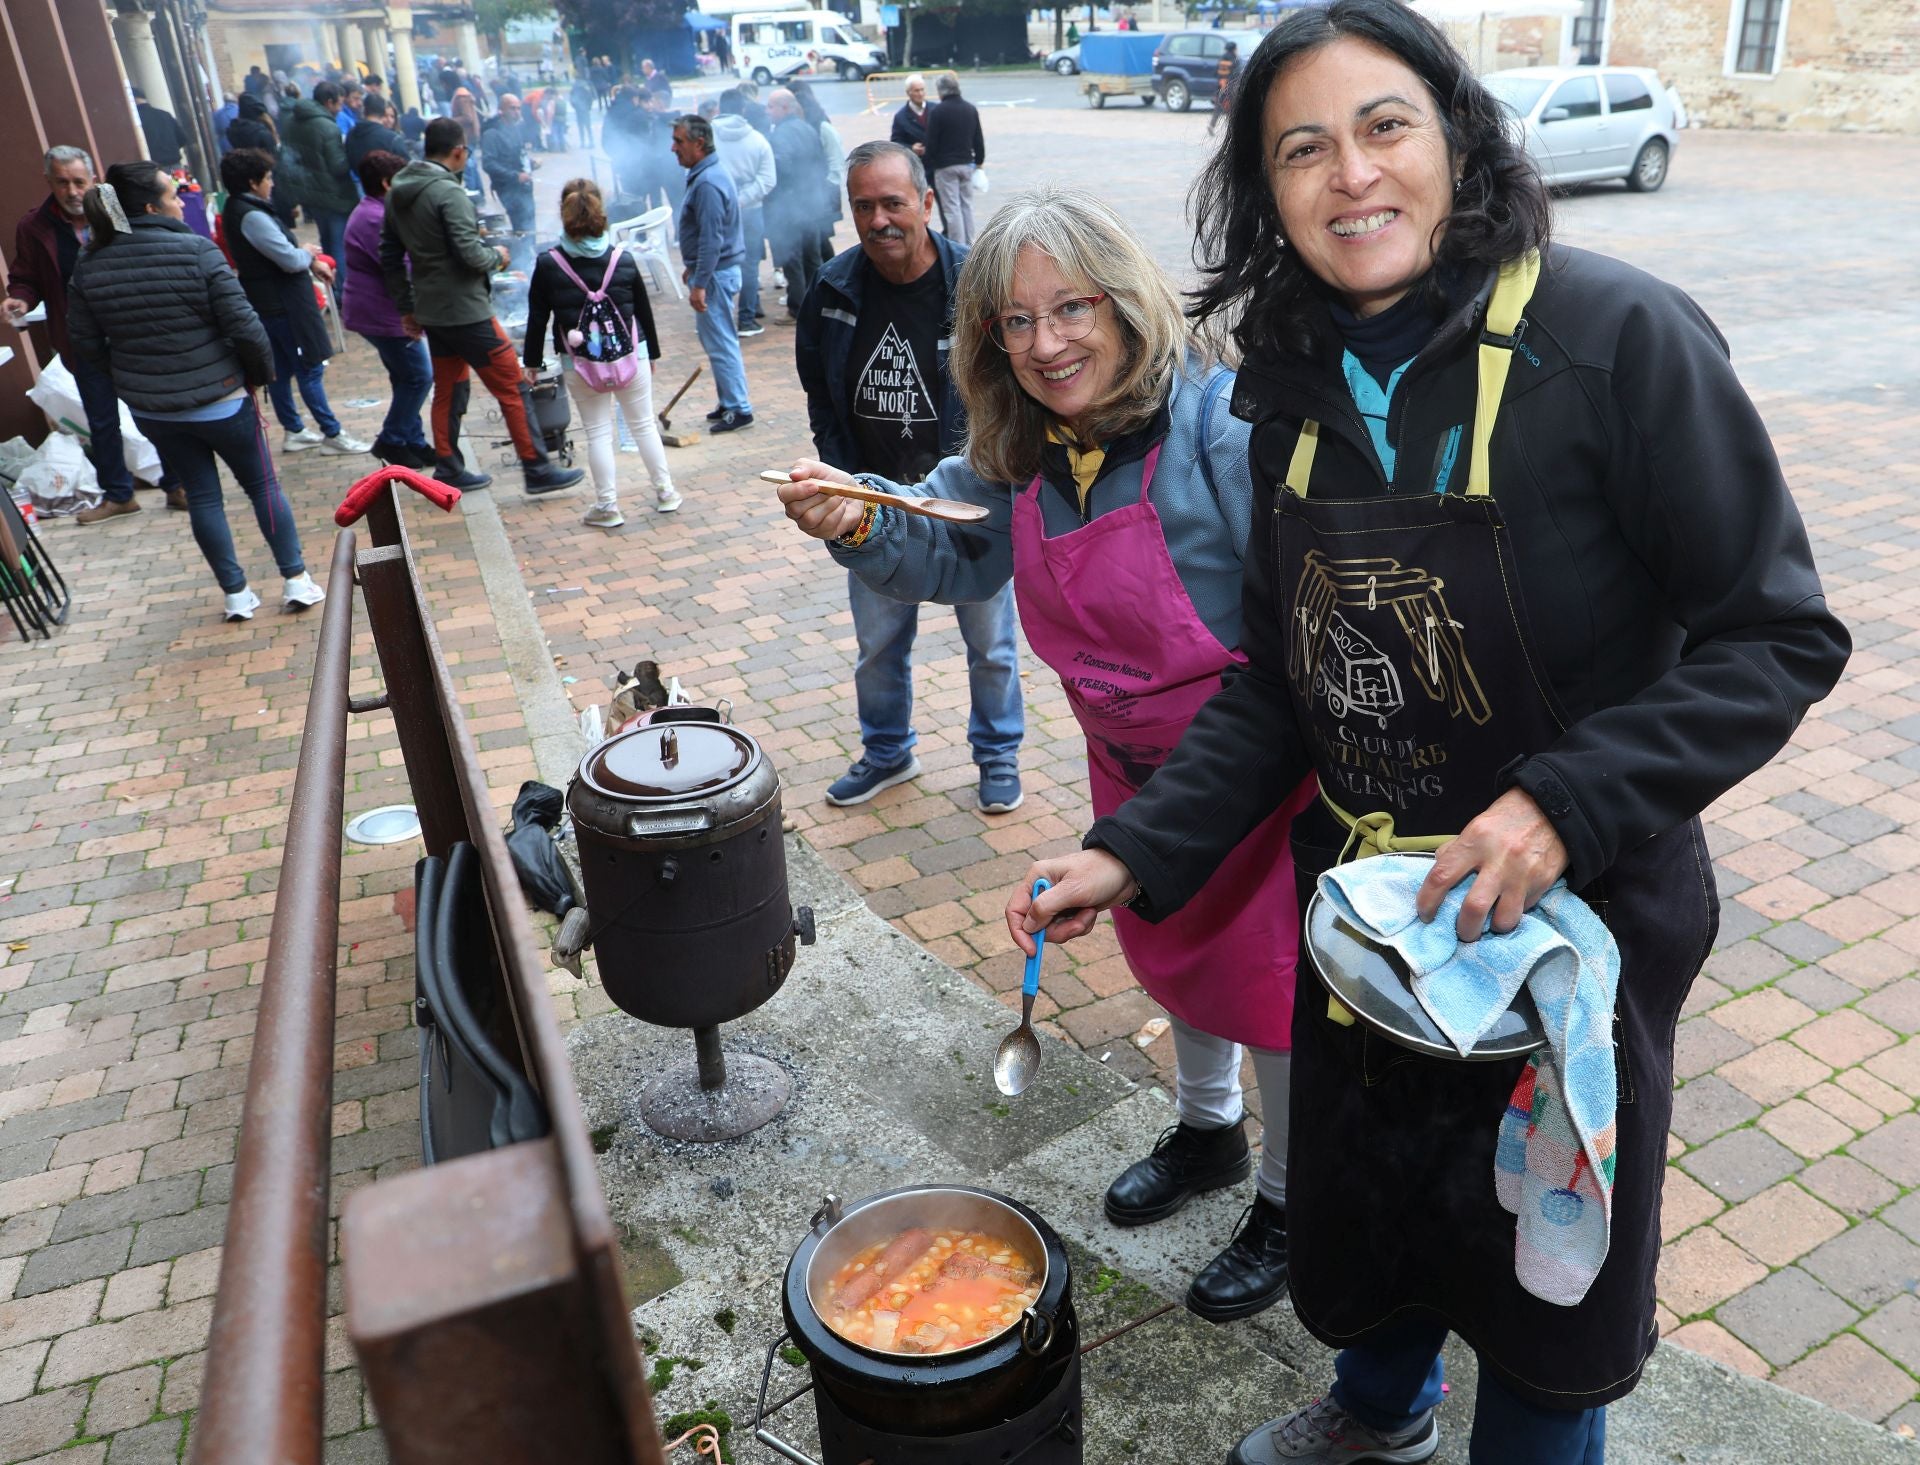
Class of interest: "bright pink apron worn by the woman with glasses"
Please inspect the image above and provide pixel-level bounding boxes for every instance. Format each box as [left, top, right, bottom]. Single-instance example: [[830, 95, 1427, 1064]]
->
[[1014, 445, 1315, 1048]]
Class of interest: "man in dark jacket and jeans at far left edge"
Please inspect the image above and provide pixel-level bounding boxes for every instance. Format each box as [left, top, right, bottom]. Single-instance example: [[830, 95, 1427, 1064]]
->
[[0, 148, 186, 524]]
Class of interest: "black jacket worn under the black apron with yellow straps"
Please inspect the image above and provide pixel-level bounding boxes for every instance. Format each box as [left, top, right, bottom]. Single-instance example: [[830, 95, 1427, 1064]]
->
[[1087, 248, 1851, 918]]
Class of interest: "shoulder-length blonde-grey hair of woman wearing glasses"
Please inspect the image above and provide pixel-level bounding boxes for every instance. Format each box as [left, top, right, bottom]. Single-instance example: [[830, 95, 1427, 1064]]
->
[[948, 188, 1192, 484]]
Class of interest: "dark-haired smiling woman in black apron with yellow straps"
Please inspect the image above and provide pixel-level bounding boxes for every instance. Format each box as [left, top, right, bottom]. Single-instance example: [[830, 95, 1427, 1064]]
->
[[1008, 0, 1849, 1465]]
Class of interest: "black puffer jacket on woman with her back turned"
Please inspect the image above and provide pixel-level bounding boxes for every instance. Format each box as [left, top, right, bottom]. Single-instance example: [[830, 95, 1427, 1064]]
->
[[67, 213, 273, 413]]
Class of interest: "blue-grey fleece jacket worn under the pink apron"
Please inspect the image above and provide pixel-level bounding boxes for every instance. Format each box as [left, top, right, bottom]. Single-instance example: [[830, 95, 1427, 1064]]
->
[[828, 359, 1254, 647]]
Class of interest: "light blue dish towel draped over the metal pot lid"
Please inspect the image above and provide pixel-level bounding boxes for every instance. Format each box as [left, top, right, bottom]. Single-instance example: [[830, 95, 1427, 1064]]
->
[[1319, 856, 1620, 1308]]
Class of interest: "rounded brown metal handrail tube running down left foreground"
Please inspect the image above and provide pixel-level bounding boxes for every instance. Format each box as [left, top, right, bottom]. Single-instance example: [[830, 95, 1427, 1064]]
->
[[192, 530, 353, 1465]]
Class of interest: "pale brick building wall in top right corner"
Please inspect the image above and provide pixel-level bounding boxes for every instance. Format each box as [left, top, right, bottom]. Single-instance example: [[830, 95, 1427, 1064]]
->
[[1607, 0, 1920, 132]]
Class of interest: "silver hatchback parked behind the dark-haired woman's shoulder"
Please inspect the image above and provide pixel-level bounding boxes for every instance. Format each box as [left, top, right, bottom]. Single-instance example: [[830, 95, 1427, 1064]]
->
[[1480, 65, 1680, 194]]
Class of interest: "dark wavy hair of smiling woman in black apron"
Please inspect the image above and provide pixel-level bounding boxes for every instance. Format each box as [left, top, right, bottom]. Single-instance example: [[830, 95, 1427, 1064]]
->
[[1187, 0, 1551, 364]]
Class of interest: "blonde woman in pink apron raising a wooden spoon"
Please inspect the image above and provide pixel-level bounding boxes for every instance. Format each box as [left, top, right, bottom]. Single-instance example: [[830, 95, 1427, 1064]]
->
[[781, 190, 1313, 1321]]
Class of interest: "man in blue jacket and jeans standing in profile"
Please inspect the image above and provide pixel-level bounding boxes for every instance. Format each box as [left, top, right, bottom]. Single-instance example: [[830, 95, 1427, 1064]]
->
[[674, 115, 753, 432]]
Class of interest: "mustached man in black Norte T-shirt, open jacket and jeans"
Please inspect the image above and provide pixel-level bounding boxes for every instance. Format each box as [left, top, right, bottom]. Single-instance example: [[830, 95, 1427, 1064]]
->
[[793, 142, 1025, 814]]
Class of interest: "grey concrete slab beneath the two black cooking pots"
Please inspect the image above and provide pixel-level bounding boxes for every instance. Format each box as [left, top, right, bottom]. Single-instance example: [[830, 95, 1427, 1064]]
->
[[568, 839, 1920, 1465]]
